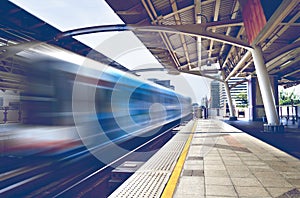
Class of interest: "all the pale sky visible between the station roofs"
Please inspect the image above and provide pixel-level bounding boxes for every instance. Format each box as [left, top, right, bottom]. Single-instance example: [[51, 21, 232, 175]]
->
[[11, 0, 210, 104]]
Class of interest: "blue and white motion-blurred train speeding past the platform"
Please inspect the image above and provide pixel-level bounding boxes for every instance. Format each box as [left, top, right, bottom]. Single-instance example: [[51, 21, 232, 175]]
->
[[7, 54, 191, 156]]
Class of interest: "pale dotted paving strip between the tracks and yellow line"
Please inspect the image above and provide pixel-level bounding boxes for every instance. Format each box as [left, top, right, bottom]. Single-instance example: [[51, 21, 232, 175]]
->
[[109, 121, 194, 198]]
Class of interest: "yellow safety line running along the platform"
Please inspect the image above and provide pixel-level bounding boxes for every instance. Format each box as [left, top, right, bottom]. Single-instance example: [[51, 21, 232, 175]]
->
[[161, 120, 198, 198]]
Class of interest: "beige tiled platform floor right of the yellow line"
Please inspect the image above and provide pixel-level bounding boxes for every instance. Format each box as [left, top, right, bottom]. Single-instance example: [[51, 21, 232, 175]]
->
[[174, 120, 300, 198]]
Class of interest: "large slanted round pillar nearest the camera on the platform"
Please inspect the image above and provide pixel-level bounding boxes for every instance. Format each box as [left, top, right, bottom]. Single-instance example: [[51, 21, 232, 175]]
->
[[251, 46, 279, 126]]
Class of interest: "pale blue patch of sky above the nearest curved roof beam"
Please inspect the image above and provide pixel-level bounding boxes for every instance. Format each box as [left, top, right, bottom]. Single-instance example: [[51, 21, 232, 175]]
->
[[10, 0, 123, 31]]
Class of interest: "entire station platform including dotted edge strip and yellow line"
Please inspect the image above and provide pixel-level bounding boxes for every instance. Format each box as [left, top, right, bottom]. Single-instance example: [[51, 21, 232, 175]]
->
[[110, 119, 300, 198]]
